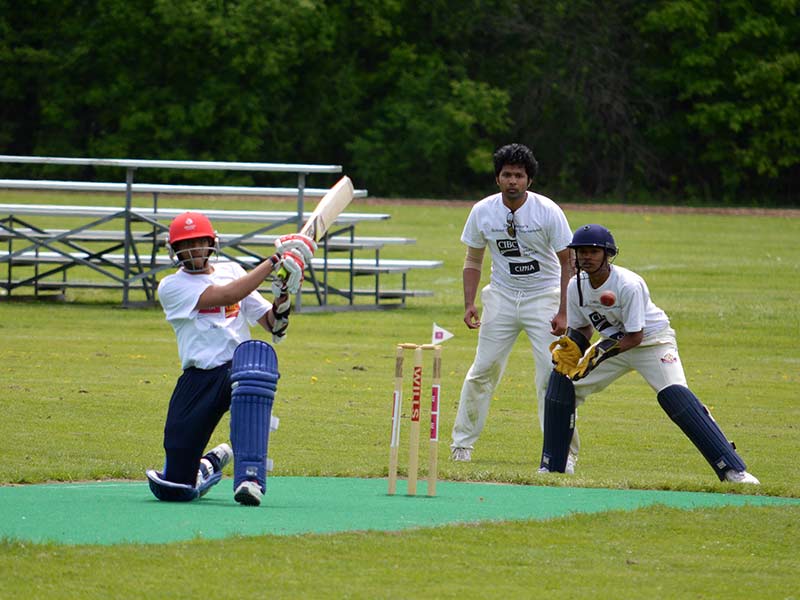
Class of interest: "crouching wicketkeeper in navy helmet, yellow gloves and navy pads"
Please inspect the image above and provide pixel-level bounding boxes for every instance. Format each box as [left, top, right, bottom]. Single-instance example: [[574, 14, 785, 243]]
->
[[539, 225, 759, 484]]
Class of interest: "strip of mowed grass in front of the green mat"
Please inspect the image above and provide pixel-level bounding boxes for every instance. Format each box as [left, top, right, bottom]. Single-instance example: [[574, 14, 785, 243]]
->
[[2, 506, 799, 600]]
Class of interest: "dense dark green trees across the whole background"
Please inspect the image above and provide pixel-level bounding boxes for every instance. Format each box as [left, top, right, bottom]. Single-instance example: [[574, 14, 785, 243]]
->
[[0, 0, 800, 204]]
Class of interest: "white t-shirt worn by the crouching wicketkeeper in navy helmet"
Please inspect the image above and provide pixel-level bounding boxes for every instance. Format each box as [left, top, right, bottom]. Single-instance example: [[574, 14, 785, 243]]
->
[[567, 265, 669, 346]]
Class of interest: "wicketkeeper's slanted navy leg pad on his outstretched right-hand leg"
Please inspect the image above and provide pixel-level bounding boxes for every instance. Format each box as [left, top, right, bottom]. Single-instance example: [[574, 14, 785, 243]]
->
[[658, 385, 746, 481]]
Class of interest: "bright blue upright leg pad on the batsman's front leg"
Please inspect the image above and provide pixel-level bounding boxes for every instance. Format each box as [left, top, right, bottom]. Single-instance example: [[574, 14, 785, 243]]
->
[[231, 340, 280, 492]]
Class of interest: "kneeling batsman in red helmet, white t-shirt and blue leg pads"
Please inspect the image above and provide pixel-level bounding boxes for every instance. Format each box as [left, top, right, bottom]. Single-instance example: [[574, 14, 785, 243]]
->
[[147, 213, 317, 506]]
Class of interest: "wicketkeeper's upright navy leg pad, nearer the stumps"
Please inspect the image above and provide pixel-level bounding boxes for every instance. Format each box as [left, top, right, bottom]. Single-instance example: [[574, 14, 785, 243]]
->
[[540, 371, 575, 473]]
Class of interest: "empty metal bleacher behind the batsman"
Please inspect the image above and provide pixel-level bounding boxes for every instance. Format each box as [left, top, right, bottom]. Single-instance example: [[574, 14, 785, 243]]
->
[[0, 156, 442, 310]]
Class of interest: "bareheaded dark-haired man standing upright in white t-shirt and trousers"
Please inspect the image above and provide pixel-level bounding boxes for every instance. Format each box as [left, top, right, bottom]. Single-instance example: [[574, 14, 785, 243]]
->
[[451, 144, 578, 461]]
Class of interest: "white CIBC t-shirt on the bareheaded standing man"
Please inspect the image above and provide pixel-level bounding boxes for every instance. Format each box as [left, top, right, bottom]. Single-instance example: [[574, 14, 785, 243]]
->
[[461, 192, 572, 292]]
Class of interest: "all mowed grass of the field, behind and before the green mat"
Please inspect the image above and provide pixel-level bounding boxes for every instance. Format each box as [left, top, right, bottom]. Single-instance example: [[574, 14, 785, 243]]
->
[[0, 194, 800, 598]]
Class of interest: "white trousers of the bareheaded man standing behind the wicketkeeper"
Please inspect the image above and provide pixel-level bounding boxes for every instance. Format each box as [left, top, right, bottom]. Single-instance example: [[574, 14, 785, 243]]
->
[[451, 285, 580, 450]]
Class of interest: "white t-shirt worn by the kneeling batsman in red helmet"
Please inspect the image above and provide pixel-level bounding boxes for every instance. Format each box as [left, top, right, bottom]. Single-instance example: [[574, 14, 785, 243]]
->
[[158, 261, 272, 369]]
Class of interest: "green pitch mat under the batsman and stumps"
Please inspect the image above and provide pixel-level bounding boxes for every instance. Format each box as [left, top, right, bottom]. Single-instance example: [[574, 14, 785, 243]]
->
[[0, 477, 800, 544]]
